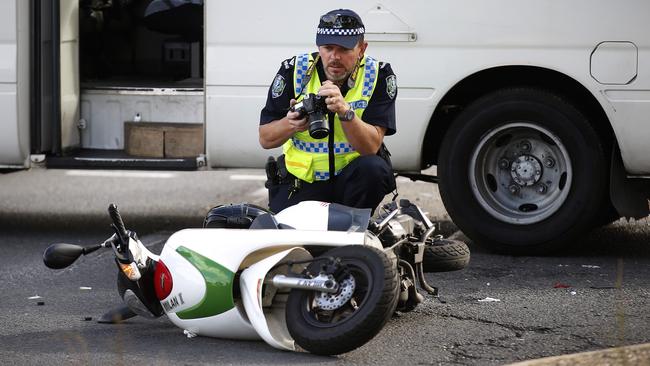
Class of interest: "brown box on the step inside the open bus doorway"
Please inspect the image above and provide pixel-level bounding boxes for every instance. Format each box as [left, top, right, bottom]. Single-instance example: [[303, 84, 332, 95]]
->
[[124, 122, 205, 158]]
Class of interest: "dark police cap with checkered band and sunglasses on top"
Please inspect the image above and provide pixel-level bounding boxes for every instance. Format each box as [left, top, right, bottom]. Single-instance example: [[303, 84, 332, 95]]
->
[[316, 9, 365, 48]]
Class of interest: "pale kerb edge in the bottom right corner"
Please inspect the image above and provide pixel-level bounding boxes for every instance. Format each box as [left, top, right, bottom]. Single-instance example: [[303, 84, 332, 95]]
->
[[508, 343, 650, 366]]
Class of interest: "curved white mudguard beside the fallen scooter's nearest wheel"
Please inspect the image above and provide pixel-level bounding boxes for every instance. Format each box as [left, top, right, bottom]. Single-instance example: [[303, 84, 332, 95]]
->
[[239, 247, 312, 350]]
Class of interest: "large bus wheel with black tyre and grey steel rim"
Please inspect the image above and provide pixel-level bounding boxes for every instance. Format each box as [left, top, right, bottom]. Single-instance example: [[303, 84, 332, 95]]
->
[[438, 88, 607, 254]]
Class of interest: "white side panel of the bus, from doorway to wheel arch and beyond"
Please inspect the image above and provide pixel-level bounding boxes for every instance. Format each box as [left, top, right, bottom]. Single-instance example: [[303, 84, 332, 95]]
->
[[206, 0, 650, 174]]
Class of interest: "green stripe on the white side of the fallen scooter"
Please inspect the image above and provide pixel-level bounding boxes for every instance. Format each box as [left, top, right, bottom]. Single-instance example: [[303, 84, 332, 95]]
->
[[176, 246, 235, 319]]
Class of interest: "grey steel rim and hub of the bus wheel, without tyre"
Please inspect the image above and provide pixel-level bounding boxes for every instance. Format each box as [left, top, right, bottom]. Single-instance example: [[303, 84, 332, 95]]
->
[[469, 122, 573, 225]]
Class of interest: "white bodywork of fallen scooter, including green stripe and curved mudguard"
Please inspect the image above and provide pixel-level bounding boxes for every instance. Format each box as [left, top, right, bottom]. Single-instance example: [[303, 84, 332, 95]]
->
[[160, 229, 365, 340]]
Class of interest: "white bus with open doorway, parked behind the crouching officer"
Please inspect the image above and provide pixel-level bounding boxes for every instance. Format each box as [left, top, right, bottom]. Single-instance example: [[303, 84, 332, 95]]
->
[[0, 0, 650, 253]]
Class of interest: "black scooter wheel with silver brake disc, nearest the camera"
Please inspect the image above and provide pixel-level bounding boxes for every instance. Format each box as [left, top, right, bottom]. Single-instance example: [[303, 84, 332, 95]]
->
[[286, 245, 399, 355]]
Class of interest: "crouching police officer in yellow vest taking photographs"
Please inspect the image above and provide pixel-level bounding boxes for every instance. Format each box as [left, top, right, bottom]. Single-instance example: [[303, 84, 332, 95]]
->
[[259, 9, 397, 212]]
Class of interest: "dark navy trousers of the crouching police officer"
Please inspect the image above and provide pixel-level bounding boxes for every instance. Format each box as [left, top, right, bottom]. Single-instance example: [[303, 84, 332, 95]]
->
[[269, 155, 395, 213]]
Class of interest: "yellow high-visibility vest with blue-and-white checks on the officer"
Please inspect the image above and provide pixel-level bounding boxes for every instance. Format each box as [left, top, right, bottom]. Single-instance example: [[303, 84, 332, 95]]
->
[[282, 54, 379, 183]]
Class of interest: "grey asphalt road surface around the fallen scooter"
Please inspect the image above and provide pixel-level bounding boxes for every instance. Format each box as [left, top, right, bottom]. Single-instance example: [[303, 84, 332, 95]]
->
[[0, 170, 650, 365]]
